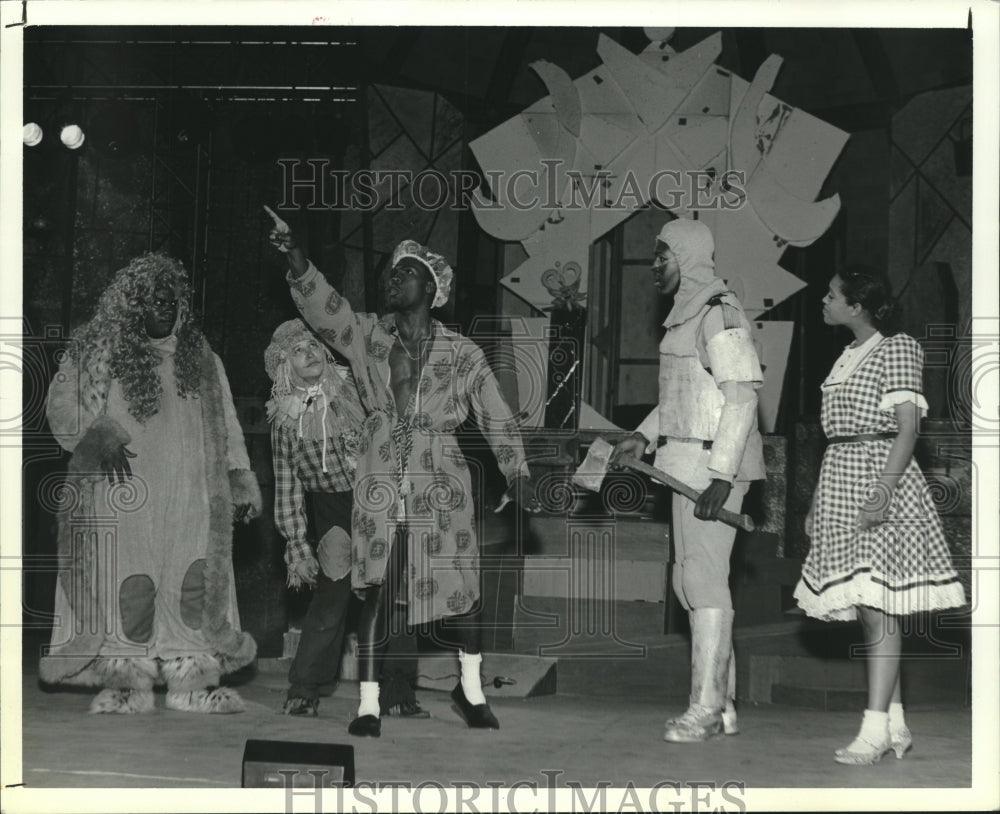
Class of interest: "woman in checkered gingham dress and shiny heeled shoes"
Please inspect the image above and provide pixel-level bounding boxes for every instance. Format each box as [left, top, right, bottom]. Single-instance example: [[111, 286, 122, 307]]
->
[[795, 266, 965, 764]]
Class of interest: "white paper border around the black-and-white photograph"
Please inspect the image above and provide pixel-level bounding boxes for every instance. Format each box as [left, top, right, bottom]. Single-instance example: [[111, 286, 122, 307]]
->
[[0, 0, 1000, 812]]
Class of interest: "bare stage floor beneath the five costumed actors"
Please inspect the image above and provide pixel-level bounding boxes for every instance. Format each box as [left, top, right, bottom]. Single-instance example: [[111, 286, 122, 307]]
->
[[15, 659, 971, 788]]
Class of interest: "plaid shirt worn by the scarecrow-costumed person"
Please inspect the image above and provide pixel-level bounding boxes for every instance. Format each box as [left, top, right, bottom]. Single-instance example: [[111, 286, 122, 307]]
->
[[271, 376, 364, 565]]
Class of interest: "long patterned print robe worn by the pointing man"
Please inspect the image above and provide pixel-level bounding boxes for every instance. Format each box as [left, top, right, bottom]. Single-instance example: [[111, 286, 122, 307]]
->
[[288, 263, 524, 625]]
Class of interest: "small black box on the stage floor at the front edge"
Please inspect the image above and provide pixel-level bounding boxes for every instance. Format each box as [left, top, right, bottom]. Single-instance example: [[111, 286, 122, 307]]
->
[[242, 740, 354, 789]]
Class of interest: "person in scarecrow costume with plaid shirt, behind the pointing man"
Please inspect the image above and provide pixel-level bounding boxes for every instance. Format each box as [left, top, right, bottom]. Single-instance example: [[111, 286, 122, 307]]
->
[[264, 319, 429, 717]]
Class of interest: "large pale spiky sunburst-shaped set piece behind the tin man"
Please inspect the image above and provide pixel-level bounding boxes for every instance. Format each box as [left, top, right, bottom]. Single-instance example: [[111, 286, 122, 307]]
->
[[470, 28, 848, 427]]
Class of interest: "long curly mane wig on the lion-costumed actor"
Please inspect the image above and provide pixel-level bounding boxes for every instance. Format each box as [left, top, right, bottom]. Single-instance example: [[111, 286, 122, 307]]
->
[[70, 253, 205, 422]]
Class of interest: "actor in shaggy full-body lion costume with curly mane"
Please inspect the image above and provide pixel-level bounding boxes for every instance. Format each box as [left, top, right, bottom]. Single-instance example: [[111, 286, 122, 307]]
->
[[40, 254, 261, 713]]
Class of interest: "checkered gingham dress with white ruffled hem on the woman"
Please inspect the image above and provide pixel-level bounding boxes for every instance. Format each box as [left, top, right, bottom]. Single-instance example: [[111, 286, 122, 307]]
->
[[795, 334, 965, 621]]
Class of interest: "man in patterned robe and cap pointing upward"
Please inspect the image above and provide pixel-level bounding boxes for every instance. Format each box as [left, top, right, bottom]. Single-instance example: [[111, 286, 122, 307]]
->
[[268, 210, 530, 737]]
